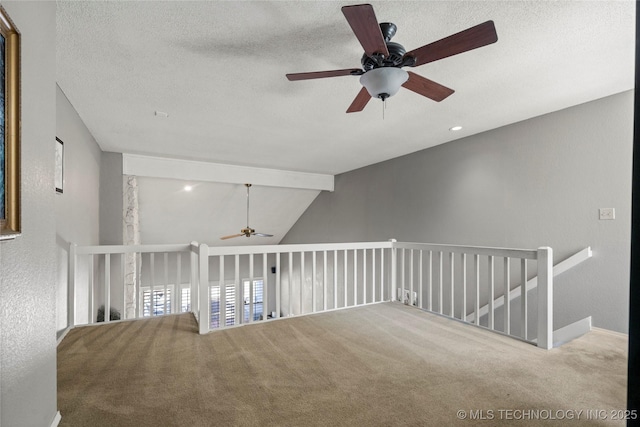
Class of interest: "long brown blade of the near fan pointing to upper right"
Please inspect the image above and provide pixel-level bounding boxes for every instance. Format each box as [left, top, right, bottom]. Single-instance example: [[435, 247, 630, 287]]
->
[[405, 21, 498, 67]]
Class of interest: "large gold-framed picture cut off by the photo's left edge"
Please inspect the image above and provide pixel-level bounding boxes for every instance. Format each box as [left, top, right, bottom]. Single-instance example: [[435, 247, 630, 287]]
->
[[0, 6, 22, 239]]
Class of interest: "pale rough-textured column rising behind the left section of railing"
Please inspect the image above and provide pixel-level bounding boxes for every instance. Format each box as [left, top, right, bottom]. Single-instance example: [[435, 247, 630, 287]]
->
[[122, 176, 140, 319]]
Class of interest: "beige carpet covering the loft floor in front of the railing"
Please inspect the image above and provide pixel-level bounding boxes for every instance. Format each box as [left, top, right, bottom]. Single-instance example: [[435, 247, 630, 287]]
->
[[58, 303, 627, 426]]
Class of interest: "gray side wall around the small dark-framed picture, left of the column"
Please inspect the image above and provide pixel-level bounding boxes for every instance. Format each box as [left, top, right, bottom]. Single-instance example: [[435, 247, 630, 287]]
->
[[55, 85, 102, 333]]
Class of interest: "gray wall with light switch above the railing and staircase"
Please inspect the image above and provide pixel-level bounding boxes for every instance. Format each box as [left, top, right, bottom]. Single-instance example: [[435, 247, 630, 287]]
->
[[282, 92, 633, 332]]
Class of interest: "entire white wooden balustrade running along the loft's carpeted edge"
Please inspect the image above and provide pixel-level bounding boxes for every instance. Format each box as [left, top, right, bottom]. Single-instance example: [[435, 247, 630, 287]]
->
[[68, 240, 576, 349]]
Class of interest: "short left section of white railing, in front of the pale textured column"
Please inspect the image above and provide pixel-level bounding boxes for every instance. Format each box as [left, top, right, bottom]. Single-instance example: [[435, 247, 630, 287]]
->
[[67, 243, 198, 327]]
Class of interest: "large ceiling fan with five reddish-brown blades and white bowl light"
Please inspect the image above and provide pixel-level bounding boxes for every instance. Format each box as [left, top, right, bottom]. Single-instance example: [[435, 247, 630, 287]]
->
[[287, 4, 498, 113]]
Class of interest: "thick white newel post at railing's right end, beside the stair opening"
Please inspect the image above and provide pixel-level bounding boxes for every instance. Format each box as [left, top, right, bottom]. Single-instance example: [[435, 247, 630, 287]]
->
[[536, 247, 553, 350]]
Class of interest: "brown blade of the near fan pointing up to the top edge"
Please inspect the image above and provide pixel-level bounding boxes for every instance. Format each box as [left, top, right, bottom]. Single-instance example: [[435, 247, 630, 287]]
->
[[342, 4, 389, 58]]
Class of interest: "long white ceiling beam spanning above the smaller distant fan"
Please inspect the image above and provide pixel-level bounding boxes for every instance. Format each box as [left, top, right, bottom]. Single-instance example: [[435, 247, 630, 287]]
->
[[122, 154, 334, 191]]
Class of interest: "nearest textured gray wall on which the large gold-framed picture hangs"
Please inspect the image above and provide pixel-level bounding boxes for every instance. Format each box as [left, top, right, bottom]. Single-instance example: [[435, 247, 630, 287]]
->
[[0, 1, 56, 427]]
